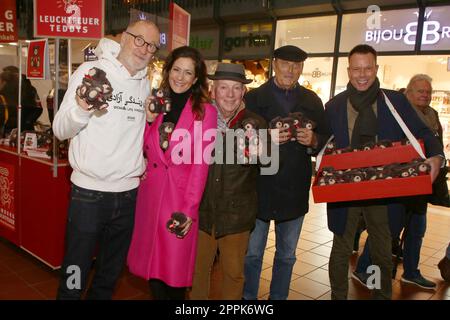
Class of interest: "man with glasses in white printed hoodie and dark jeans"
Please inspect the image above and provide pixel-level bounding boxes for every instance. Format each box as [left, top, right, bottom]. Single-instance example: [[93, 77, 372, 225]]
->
[[53, 21, 159, 300]]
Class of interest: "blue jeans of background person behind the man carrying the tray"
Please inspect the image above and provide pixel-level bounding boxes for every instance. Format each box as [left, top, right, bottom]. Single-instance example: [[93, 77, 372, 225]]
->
[[356, 207, 427, 279]]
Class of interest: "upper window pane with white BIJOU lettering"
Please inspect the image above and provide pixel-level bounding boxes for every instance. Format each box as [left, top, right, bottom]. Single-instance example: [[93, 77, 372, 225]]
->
[[339, 9, 419, 52]]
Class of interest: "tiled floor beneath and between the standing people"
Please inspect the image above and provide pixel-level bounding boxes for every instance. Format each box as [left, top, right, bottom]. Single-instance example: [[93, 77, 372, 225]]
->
[[0, 192, 450, 300]]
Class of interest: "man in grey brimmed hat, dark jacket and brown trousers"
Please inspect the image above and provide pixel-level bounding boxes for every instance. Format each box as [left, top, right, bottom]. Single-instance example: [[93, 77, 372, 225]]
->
[[190, 63, 267, 300]]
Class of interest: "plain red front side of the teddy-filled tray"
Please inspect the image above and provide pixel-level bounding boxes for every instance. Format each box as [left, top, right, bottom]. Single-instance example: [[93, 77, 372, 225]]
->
[[312, 175, 432, 203]]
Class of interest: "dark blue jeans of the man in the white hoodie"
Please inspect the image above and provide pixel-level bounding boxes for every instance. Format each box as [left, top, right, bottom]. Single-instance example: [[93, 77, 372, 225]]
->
[[57, 185, 137, 300]]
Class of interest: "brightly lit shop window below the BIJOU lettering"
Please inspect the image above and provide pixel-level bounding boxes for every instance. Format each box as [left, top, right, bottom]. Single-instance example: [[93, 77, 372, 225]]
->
[[334, 55, 450, 158]]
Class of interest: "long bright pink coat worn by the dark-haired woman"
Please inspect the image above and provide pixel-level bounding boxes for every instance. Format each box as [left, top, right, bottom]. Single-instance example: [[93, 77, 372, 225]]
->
[[127, 100, 217, 287]]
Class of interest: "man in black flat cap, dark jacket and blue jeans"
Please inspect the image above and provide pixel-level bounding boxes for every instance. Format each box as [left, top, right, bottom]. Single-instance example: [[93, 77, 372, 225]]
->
[[243, 45, 329, 300]]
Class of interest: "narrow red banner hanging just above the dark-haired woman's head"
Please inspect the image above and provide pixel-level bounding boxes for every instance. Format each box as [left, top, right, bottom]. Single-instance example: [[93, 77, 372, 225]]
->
[[169, 2, 191, 51]]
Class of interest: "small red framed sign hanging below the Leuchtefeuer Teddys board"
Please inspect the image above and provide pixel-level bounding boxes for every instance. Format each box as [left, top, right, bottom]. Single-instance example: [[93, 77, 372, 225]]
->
[[27, 39, 49, 79]]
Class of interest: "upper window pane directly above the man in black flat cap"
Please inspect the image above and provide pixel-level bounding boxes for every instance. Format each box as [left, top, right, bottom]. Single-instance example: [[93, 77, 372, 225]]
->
[[275, 16, 337, 53]]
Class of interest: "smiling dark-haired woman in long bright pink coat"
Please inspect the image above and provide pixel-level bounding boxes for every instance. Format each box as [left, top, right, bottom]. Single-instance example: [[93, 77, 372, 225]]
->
[[128, 47, 217, 300]]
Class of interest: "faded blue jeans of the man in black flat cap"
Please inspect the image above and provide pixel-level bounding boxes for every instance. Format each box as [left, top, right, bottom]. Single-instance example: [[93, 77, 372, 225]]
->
[[243, 216, 304, 300]]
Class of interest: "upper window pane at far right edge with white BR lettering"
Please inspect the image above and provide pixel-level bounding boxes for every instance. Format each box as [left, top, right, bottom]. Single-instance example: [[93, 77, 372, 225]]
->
[[421, 6, 450, 50]]
